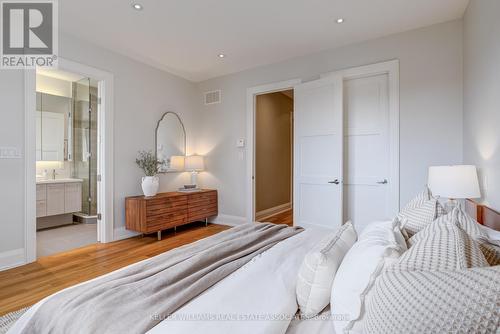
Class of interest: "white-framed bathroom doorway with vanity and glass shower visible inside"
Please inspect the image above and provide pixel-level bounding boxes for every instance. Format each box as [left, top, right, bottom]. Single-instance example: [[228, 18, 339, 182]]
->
[[24, 58, 115, 263]]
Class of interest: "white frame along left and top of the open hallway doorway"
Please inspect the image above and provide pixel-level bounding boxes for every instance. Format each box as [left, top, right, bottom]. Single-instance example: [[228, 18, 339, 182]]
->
[[245, 79, 302, 222]]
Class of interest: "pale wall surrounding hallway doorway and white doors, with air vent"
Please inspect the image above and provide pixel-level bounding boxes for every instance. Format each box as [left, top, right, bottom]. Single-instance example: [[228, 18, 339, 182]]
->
[[197, 20, 463, 217]]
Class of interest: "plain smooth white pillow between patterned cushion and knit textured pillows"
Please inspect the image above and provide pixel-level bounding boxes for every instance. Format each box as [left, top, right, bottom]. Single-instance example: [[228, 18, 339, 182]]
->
[[330, 220, 406, 333]]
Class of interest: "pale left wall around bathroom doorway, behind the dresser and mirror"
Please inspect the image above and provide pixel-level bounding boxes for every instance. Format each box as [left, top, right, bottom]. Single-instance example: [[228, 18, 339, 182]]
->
[[0, 36, 198, 267]]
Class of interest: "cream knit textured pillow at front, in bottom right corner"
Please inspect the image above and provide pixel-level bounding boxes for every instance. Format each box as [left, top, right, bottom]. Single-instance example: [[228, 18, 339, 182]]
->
[[364, 266, 500, 334]]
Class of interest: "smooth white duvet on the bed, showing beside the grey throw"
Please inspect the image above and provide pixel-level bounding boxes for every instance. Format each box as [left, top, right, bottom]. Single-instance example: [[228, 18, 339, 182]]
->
[[8, 228, 331, 334]]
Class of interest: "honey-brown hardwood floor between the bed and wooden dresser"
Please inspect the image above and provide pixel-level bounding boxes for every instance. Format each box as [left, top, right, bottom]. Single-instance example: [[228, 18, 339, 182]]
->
[[0, 223, 229, 315]]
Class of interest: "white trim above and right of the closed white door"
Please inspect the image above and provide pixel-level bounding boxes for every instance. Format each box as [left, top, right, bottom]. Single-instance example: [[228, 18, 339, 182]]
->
[[321, 59, 400, 215]]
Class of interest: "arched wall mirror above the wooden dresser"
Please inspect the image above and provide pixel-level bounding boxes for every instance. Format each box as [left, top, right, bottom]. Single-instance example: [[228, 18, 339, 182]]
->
[[155, 111, 186, 173]]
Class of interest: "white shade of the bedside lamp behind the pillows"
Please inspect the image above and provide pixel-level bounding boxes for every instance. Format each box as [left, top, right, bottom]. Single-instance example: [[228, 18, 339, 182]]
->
[[428, 165, 481, 199]]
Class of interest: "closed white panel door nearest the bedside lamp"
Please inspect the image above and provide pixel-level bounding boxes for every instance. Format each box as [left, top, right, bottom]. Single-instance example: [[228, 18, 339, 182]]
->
[[344, 73, 394, 232]]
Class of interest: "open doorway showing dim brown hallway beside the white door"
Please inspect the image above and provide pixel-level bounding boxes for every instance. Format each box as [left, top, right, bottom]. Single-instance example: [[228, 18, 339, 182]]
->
[[254, 90, 293, 226]]
